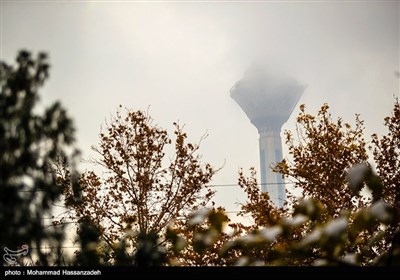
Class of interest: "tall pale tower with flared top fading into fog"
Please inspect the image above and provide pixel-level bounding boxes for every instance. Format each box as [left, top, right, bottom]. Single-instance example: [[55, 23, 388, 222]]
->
[[230, 65, 305, 207]]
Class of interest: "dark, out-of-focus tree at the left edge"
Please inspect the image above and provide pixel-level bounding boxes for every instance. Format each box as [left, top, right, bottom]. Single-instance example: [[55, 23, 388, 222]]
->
[[0, 51, 77, 265]]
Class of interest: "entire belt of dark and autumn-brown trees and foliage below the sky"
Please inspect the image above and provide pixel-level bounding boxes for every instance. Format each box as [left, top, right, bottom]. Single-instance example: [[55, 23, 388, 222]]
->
[[0, 51, 400, 266]]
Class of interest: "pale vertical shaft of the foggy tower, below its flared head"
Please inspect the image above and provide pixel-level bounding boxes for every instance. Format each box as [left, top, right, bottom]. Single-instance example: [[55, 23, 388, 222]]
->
[[259, 130, 286, 207]]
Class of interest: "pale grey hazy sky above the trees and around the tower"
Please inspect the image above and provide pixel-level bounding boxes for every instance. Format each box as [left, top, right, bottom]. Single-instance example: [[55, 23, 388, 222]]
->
[[1, 0, 400, 217]]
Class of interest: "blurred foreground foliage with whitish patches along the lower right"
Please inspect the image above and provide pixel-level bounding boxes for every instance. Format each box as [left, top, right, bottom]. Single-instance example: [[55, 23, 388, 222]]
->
[[165, 163, 400, 266]]
